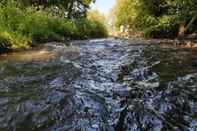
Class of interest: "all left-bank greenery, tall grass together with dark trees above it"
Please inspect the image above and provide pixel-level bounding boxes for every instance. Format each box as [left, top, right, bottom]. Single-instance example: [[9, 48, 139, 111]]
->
[[0, 0, 107, 53]]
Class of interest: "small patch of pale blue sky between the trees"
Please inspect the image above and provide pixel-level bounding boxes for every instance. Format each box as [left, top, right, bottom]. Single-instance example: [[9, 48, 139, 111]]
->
[[91, 0, 116, 14]]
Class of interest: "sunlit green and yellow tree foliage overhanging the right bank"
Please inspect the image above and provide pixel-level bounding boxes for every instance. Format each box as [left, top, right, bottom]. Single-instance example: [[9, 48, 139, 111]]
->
[[113, 0, 197, 37]]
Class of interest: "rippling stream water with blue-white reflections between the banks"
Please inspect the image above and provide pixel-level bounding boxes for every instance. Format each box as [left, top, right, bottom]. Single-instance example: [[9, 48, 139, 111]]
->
[[0, 39, 197, 131]]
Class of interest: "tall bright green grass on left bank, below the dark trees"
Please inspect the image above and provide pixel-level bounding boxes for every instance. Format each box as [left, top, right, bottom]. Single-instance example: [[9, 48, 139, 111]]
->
[[0, 2, 107, 52]]
